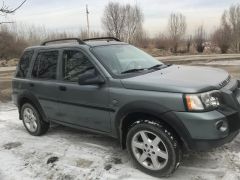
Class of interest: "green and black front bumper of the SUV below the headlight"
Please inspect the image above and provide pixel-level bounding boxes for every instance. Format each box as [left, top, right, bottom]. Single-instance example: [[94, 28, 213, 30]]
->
[[175, 107, 240, 150]]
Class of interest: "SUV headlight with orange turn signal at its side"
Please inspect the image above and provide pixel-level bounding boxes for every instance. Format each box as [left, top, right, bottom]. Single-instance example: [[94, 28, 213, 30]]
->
[[185, 91, 221, 111]]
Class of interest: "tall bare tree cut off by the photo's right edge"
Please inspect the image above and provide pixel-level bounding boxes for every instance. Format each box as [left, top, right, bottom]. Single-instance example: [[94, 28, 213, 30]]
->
[[222, 4, 240, 52]]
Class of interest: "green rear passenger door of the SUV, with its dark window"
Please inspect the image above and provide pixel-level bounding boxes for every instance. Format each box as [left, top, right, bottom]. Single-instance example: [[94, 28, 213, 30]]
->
[[29, 50, 60, 119]]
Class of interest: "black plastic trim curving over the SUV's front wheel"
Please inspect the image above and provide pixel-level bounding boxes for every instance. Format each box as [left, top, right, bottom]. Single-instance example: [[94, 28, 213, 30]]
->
[[115, 101, 192, 149]]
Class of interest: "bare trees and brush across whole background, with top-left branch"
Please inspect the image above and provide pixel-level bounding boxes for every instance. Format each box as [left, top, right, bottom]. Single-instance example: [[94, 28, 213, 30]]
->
[[0, 0, 240, 59]]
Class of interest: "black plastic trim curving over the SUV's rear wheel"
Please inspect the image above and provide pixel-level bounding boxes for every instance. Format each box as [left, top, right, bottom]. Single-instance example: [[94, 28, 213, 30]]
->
[[17, 90, 49, 122]]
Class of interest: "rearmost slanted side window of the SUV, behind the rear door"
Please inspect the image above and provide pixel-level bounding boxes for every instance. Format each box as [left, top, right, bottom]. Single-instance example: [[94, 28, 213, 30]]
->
[[16, 51, 33, 78]]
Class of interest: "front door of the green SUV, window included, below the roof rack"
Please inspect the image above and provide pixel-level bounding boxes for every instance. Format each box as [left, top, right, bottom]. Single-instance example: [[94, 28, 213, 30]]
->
[[58, 49, 111, 132]]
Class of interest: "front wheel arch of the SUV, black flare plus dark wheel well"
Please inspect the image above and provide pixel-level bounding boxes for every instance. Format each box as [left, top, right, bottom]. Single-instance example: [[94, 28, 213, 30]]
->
[[115, 101, 190, 149]]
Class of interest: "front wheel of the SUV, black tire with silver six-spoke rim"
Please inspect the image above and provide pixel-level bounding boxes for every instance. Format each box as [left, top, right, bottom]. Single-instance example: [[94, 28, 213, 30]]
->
[[126, 120, 182, 177]]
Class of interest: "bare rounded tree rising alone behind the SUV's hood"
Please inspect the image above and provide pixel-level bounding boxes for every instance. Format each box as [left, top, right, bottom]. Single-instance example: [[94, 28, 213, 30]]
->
[[168, 13, 187, 53]]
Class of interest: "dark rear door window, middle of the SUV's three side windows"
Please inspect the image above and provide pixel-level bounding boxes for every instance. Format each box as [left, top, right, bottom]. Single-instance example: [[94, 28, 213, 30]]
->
[[32, 51, 58, 79]]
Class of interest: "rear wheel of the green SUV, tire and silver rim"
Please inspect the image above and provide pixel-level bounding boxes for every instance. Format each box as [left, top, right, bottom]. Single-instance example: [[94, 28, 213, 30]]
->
[[21, 103, 49, 136]]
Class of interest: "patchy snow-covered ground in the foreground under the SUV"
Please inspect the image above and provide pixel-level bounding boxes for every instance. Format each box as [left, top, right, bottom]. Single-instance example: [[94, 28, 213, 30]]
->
[[0, 103, 240, 180]]
